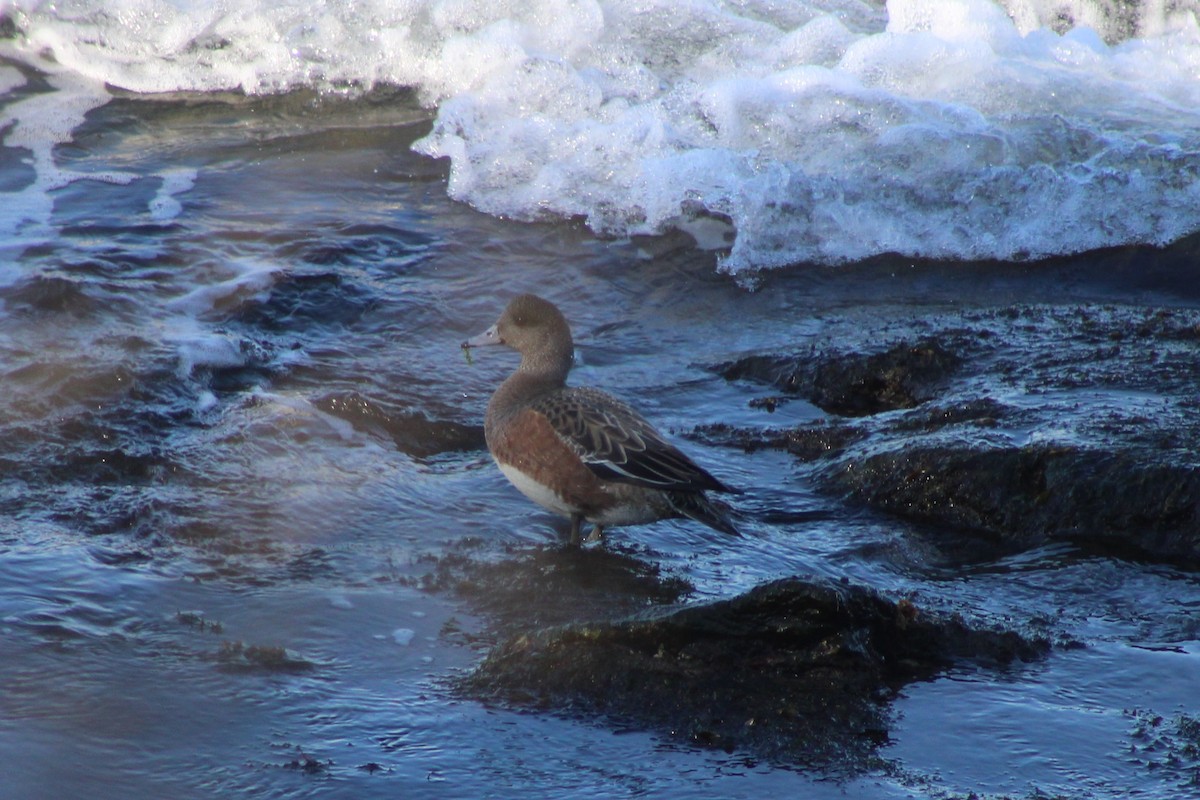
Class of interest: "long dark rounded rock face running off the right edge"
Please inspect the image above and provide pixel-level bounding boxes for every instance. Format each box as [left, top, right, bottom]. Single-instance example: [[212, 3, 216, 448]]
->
[[827, 446, 1200, 564]]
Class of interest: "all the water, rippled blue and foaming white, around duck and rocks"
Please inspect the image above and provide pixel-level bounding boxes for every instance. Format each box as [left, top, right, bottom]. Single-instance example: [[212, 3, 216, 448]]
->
[[0, 0, 1200, 798]]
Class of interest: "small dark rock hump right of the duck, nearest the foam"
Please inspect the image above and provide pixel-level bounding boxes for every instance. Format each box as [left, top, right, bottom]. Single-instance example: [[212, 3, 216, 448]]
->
[[716, 338, 962, 416]]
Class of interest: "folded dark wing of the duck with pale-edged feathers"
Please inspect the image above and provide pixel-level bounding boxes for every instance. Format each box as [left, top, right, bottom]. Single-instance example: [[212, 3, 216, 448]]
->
[[532, 389, 733, 492]]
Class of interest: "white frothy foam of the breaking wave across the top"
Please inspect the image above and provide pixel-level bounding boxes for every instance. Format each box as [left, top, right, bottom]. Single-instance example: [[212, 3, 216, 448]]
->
[[0, 0, 1200, 271]]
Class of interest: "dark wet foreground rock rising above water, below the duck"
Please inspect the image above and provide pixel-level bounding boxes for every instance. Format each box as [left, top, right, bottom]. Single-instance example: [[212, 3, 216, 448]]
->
[[462, 579, 1049, 771]]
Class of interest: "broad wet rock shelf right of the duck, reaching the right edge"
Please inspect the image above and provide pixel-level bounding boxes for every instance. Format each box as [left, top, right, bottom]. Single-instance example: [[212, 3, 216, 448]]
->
[[698, 305, 1200, 567]]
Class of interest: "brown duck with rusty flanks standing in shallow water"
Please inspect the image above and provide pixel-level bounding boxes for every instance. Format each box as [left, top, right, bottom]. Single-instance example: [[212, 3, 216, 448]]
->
[[462, 294, 738, 545]]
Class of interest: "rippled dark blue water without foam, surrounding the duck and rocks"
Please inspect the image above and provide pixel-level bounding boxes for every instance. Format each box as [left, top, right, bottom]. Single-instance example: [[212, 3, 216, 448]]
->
[[7, 83, 1200, 798]]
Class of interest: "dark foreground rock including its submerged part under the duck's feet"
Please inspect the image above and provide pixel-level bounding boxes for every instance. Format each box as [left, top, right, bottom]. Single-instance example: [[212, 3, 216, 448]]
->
[[422, 545, 1050, 772]]
